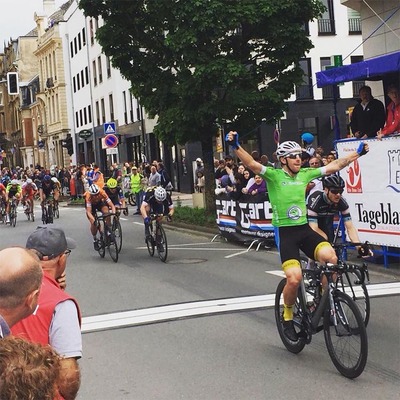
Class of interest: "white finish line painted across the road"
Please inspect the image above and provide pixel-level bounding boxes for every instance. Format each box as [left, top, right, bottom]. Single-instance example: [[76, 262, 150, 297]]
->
[[82, 280, 400, 333]]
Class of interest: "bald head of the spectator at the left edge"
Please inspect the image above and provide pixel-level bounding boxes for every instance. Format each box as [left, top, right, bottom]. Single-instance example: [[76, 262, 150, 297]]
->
[[0, 247, 43, 339]]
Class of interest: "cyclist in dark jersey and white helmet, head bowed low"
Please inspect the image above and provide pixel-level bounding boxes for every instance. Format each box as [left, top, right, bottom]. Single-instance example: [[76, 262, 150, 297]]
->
[[140, 186, 174, 239]]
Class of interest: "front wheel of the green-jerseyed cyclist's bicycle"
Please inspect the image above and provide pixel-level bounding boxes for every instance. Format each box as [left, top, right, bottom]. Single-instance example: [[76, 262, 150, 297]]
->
[[324, 291, 368, 379]]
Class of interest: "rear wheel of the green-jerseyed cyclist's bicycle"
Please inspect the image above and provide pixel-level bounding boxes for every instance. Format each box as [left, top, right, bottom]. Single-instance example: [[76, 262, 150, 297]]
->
[[275, 278, 306, 354]]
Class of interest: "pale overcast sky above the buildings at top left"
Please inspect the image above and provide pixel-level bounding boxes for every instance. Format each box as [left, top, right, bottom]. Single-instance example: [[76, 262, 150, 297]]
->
[[0, 0, 66, 52]]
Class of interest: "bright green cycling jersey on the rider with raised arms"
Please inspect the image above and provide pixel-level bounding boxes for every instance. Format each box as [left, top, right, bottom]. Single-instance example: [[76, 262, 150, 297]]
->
[[260, 166, 325, 227]]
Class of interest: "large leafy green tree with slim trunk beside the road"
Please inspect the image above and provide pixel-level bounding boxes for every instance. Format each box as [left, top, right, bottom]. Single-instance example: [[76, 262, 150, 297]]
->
[[80, 0, 323, 210]]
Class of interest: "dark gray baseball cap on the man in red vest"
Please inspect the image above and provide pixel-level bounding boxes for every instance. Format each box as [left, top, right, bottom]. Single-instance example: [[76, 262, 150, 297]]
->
[[26, 226, 76, 258]]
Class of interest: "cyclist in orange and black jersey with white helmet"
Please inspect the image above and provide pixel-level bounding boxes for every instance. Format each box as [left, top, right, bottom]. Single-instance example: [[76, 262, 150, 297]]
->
[[83, 183, 115, 251]]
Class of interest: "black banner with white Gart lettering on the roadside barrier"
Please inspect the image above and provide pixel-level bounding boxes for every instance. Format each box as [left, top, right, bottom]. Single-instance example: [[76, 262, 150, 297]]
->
[[216, 194, 275, 242]]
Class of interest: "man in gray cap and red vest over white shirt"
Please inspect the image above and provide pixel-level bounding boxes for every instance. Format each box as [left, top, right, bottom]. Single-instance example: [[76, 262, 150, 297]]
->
[[11, 226, 82, 400]]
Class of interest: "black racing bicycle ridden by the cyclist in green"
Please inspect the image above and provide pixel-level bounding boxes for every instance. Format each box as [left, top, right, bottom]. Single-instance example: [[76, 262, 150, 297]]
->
[[275, 263, 368, 379]]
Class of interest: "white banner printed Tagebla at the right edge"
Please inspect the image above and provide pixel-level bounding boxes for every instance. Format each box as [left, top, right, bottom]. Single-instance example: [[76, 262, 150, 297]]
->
[[336, 136, 400, 247]]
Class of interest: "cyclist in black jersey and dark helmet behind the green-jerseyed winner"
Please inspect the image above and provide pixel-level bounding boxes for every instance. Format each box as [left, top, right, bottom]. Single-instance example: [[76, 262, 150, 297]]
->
[[307, 174, 370, 257]]
